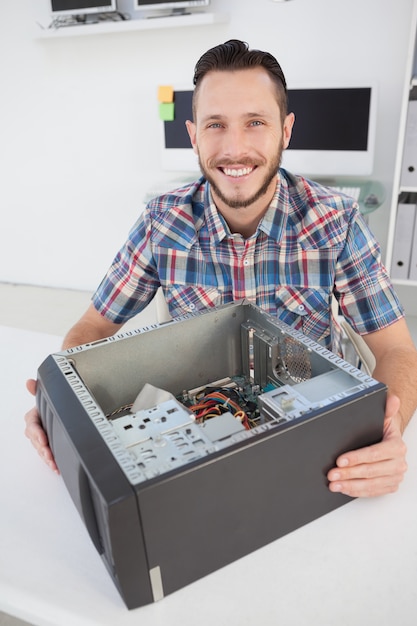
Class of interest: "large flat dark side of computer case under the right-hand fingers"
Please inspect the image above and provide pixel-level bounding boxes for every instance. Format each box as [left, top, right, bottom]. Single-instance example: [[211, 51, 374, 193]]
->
[[138, 385, 386, 595]]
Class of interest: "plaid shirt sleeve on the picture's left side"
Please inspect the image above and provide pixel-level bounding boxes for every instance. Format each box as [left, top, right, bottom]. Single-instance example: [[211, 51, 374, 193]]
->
[[92, 209, 159, 324]]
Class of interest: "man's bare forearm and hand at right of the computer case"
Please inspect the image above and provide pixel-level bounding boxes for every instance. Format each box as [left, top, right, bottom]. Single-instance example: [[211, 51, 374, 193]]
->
[[328, 319, 417, 497]]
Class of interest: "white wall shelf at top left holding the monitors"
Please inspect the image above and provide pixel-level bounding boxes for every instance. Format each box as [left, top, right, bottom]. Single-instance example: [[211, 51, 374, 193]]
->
[[37, 13, 229, 39]]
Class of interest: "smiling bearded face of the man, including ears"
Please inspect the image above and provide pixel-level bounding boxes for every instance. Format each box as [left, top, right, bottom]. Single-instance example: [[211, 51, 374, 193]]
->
[[187, 67, 294, 208]]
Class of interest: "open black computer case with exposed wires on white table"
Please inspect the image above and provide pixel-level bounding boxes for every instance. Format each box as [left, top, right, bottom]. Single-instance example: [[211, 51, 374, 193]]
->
[[37, 302, 386, 609]]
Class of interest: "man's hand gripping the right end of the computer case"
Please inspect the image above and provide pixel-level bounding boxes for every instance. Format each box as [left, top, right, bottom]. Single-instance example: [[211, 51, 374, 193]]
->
[[327, 395, 407, 497]]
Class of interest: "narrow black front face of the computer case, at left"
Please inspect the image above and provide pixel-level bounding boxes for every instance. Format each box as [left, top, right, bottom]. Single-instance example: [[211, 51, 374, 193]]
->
[[37, 356, 153, 608]]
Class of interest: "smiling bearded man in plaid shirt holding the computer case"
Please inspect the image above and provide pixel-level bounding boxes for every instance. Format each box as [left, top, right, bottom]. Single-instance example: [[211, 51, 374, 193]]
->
[[26, 40, 417, 496]]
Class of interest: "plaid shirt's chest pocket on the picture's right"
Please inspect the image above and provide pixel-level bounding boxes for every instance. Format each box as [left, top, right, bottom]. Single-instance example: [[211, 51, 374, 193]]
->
[[275, 286, 331, 345]]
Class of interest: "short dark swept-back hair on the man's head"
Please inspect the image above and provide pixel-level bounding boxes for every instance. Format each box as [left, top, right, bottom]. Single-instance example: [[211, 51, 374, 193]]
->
[[193, 39, 288, 121]]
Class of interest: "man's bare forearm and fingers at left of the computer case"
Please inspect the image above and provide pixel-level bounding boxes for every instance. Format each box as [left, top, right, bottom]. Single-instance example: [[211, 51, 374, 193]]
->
[[25, 304, 123, 472]]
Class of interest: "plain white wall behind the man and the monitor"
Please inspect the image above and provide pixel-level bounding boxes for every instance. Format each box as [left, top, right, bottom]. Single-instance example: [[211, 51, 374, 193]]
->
[[0, 0, 413, 290]]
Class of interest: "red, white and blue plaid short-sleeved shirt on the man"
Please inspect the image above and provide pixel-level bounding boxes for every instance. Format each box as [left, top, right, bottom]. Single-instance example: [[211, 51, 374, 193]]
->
[[93, 169, 403, 350]]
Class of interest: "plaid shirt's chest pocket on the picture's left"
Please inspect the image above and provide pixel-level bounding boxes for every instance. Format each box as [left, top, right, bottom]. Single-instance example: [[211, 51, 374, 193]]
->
[[165, 284, 226, 317]]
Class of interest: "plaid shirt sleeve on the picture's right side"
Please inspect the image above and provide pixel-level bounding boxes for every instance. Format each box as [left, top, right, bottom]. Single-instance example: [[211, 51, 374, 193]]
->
[[335, 210, 404, 335]]
